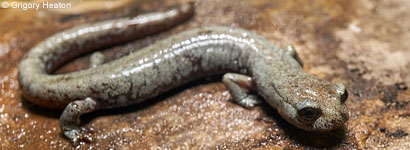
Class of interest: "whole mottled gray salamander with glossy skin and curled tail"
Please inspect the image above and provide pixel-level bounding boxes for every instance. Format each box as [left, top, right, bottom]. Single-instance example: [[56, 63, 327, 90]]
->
[[18, 4, 348, 144]]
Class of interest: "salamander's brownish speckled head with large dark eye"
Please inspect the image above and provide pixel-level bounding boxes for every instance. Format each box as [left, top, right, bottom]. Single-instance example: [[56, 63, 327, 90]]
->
[[279, 78, 349, 131]]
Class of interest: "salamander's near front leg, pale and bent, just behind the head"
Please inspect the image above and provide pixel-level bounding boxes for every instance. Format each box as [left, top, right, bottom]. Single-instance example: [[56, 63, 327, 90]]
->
[[222, 73, 260, 108]]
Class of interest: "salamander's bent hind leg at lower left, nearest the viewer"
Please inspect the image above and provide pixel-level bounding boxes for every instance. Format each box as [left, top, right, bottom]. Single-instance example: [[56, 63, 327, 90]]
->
[[60, 98, 99, 146]]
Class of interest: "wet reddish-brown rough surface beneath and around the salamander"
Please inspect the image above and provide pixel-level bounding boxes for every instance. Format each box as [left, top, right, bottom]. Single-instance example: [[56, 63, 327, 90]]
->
[[0, 0, 410, 150]]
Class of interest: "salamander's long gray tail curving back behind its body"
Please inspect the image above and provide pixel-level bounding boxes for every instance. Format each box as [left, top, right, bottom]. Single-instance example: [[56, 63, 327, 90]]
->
[[18, 3, 194, 108]]
